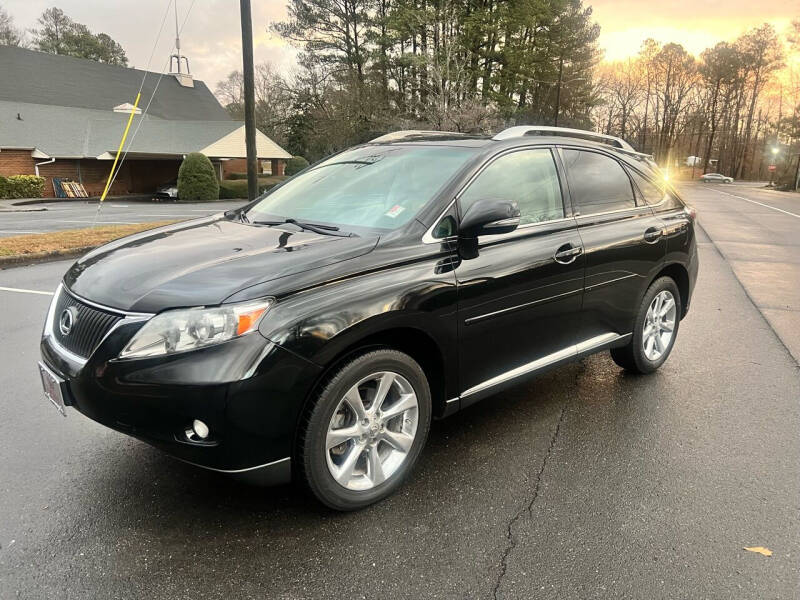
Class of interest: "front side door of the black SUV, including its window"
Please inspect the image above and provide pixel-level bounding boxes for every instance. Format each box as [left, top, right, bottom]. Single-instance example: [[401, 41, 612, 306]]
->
[[455, 147, 584, 407]]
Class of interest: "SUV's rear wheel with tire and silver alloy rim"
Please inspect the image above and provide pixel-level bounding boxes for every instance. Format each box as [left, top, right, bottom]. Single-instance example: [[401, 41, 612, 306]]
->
[[611, 277, 681, 373]]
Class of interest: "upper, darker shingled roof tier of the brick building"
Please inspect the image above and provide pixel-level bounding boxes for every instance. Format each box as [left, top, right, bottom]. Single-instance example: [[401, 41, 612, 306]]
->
[[0, 46, 231, 121]]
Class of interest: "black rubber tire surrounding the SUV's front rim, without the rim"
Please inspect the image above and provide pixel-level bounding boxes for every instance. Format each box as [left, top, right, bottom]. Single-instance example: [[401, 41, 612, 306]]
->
[[298, 349, 432, 511]]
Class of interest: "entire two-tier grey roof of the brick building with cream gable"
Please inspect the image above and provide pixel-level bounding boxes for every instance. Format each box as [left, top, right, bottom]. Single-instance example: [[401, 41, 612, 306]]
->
[[0, 46, 291, 159]]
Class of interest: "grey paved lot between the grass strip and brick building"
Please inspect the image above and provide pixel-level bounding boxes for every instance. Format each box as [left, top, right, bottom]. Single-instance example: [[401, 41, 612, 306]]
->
[[0, 200, 244, 237]]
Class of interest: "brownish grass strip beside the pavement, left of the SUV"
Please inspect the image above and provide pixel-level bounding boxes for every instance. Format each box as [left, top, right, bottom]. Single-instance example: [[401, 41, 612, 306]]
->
[[0, 221, 175, 256]]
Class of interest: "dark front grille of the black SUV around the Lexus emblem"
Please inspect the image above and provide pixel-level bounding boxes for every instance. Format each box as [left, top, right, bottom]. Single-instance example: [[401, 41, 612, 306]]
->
[[51, 288, 123, 358]]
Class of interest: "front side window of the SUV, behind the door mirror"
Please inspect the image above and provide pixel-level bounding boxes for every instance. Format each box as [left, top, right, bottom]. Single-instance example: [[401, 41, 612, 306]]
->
[[459, 148, 564, 225]]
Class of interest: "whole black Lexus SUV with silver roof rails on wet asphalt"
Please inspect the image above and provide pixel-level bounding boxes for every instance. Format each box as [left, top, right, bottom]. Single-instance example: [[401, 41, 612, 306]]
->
[[40, 127, 698, 510]]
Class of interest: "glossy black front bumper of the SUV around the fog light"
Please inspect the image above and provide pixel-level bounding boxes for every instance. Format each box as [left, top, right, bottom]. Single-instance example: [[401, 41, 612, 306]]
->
[[41, 296, 320, 483]]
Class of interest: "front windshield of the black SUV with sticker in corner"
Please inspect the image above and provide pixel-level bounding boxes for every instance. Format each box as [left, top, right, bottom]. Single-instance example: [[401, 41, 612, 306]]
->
[[247, 145, 475, 229]]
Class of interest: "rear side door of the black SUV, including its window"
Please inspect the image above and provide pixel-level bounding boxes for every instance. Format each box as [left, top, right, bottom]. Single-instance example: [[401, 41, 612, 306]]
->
[[561, 147, 666, 344]]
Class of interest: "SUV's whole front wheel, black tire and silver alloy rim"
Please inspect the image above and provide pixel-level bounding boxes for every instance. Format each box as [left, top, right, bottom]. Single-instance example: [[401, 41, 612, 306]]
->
[[300, 350, 431, 510]]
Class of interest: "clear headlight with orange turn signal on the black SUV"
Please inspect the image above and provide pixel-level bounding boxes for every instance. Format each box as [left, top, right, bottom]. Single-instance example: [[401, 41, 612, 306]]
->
[[119, 300, 273, 358]]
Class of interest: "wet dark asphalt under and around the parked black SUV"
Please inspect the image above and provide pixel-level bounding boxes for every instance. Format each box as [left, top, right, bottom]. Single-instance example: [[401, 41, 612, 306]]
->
[[0, 185, 800, 599]]
